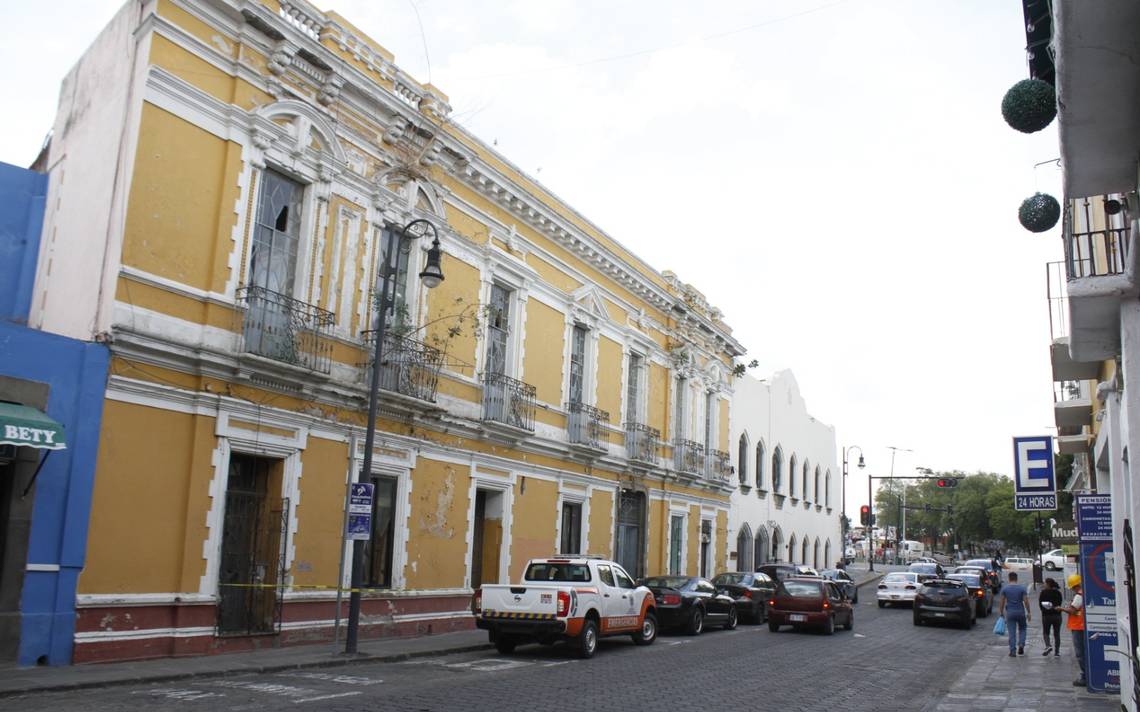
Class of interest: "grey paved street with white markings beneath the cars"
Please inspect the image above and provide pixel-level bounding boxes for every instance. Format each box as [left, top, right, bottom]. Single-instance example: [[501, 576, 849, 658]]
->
[[15, 591, 993, 712]]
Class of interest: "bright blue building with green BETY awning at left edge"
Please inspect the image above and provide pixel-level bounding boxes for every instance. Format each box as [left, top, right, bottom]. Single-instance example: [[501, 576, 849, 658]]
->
[[0, 158, 109, 665]]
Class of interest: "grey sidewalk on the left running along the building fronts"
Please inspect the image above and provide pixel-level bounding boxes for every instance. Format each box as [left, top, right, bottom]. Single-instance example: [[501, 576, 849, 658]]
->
[[0, 567, 882, 697]]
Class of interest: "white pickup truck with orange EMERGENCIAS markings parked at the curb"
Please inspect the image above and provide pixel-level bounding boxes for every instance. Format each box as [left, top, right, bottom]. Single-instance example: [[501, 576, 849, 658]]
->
[[471, 556, 657, 657]]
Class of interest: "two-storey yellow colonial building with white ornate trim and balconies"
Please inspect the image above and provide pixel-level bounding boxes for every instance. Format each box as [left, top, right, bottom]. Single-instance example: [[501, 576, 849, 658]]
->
[[32, 0, 743, 662]]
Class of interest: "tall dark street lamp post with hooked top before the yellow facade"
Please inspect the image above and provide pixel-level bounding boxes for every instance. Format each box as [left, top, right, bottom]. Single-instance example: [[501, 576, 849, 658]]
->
[[344, 220, 443, 655]]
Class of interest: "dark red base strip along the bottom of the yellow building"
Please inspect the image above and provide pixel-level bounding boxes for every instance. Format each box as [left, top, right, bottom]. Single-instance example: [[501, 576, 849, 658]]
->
[[72, 594, 474, 664]]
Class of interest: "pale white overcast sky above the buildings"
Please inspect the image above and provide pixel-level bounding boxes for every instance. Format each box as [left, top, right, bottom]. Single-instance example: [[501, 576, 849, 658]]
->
[[0, 0, 1061, 512]]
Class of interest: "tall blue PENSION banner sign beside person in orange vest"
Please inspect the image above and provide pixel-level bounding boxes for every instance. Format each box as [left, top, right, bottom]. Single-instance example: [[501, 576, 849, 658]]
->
[[1076, 494, 1121, 693]]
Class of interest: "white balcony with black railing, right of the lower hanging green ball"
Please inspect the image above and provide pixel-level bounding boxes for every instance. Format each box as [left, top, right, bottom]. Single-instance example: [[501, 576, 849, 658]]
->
[[1062, 194, 1138, 363]]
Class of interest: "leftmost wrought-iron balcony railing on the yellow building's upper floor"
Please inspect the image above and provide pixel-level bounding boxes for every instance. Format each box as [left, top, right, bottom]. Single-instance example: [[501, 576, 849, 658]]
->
[[237, 286, 336, 374]]
